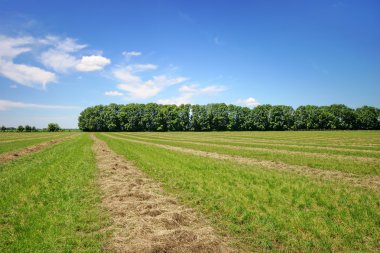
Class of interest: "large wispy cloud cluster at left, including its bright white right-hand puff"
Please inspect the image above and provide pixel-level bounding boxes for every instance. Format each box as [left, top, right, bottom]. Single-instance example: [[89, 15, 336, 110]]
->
[[0, 35, 111, 88]]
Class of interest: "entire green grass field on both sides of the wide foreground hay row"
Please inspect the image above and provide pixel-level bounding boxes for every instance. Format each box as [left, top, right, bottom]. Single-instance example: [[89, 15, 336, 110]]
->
[[0, 131, 380, 252]]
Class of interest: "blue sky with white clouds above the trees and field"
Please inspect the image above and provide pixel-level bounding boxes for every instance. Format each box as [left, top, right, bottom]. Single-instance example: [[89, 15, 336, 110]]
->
[[0, 0, 380, 128]]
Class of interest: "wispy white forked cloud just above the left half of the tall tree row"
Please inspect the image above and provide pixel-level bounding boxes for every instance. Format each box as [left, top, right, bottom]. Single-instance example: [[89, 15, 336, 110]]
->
[[113, 64, 187, 99]]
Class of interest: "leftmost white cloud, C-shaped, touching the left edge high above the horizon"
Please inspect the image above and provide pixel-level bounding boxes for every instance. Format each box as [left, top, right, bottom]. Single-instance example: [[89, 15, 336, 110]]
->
[[0, 35, 57, 88]]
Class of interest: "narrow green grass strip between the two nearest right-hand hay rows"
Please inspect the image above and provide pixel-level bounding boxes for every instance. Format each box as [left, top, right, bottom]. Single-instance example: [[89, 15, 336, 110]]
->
[[113, 134, 380, 175]]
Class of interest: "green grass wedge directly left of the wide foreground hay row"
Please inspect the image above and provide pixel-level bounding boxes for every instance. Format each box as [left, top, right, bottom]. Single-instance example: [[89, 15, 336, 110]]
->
[[0, 134, 107, 252]]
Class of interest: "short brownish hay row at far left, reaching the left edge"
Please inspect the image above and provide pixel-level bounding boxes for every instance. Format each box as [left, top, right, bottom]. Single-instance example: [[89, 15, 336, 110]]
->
[[0, 135, 76, 163]]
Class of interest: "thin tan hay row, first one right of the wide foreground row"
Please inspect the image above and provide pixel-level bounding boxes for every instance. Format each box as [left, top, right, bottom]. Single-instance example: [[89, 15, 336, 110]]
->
[[105, 134, 380, 192]]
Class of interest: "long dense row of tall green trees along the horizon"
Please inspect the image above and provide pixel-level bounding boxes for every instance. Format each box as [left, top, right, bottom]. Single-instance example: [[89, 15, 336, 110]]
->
[[78, 103, 380, 132]]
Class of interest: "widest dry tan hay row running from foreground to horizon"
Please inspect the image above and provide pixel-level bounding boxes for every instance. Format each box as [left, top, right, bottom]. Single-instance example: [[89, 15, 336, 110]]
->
[[92, 135, 235, 253]]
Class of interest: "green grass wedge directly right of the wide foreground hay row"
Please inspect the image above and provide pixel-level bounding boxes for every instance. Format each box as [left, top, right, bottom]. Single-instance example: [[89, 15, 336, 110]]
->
[[97, 134, 380, 252]]
